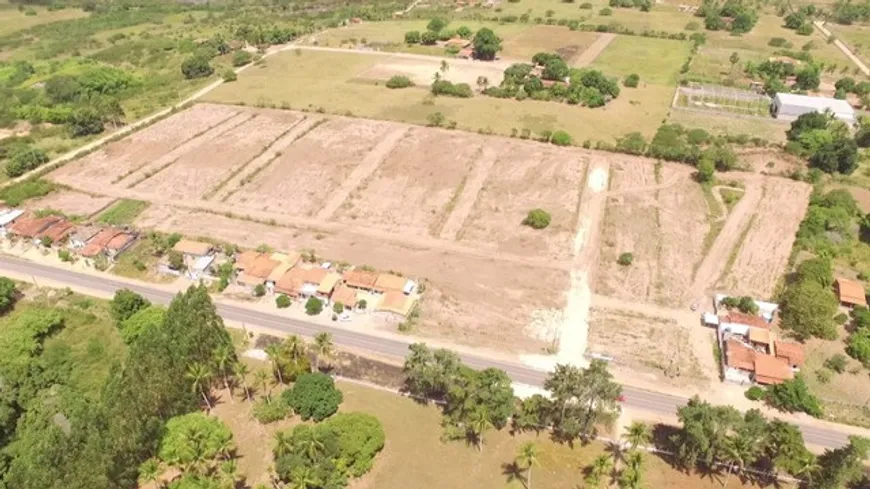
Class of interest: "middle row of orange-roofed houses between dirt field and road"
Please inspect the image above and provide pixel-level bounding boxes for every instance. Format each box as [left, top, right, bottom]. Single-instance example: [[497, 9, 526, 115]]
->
[[228, 246, 419, 317]]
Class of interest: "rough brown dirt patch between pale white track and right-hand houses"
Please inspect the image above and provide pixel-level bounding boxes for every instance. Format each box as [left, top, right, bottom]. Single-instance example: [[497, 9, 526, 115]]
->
[[589, 307, 706, 385]]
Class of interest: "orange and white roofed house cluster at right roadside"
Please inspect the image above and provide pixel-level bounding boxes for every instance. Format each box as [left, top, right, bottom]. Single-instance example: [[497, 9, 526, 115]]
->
[[704, 296, 804, 385]]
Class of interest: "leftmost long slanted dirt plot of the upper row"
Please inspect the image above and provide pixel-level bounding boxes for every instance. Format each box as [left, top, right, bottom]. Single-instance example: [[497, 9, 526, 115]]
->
[[52, 104, 240, 189]]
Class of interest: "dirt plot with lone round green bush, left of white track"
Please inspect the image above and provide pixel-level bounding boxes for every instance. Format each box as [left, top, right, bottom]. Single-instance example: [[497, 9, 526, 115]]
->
[[459, 141, 588, 259]]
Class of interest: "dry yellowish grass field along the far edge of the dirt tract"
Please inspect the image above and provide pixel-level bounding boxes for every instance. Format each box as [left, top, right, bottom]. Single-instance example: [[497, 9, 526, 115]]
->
[[206, 51, 673, 142]]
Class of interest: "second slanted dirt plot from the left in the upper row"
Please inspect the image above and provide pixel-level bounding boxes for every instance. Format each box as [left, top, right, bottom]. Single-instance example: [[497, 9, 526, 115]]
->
[[135, 111, 302, 199]]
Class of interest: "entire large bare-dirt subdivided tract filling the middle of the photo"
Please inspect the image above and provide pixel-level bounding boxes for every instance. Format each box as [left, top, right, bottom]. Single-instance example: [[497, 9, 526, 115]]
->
[[47, 104, 809, 358]]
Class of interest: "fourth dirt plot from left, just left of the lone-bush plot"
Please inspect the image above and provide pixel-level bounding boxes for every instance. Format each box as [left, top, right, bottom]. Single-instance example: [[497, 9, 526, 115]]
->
[[336, 129, 485, 235]]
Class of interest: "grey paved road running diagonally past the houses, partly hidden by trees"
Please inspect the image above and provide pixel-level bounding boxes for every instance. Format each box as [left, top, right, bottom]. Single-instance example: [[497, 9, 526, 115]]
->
[[0, 256, 847, 447]]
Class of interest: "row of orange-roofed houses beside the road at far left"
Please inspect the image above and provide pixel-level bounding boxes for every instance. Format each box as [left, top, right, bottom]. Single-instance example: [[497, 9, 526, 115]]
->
[[0, 209, 138, 260]]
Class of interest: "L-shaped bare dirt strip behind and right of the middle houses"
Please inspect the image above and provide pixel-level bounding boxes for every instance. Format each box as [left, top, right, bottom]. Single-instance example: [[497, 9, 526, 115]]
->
[[135, 206, 569, 353]]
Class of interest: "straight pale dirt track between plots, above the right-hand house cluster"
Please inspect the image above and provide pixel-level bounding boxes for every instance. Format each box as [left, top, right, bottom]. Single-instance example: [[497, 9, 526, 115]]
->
[[689, 180, 764, 302]]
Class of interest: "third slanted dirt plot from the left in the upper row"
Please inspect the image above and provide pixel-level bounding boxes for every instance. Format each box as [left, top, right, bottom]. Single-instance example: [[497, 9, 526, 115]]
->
[[227, 118, 398, 216]]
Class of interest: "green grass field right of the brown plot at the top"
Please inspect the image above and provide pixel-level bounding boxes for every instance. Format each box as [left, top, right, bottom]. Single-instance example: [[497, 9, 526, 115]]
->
[[592, 36, 691, 86]]
